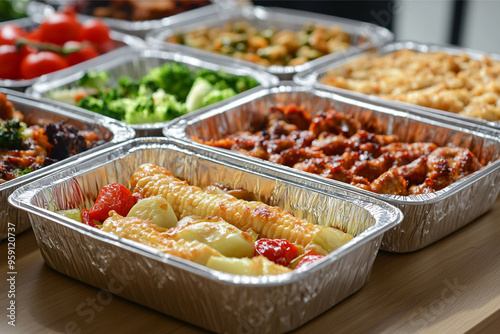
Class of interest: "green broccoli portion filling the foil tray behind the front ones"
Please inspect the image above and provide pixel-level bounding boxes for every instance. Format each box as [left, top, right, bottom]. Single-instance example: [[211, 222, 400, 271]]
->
[[48, 62, 259, 124]]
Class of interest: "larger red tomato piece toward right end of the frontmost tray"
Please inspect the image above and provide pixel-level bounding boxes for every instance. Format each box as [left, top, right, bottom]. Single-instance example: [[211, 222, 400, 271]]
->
[[255, 238, 297, 267]]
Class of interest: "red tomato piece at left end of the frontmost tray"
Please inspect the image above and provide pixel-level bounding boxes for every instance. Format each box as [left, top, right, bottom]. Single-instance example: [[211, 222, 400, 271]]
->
[[89, 183, 136, 222]]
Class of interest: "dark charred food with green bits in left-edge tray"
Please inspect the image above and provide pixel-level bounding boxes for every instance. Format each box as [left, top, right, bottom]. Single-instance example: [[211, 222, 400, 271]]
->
[[0, 93, 104, 184]]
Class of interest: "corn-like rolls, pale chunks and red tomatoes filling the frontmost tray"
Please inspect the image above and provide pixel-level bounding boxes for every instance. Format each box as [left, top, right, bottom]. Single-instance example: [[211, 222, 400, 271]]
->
[[59, 164, 353, 275]]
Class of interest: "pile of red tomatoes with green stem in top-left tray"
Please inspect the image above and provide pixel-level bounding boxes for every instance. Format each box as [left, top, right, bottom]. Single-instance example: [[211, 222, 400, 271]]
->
[[0, 10, 113, 80]]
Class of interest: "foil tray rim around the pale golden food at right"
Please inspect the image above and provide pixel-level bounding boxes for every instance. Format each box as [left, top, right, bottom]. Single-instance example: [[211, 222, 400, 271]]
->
[[293, 41, 500, 129]]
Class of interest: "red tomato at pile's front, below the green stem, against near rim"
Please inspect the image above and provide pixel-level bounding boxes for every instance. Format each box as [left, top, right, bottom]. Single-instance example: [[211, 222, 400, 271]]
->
[[21, 51, 68, 79]]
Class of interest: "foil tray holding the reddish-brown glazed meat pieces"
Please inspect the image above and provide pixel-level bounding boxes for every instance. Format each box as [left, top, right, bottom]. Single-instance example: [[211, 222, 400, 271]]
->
[[164, 82, 500, 252]]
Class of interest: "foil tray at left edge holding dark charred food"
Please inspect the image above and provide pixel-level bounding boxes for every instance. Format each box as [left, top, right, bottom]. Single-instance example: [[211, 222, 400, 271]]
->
[[0, 88, 135, 240]]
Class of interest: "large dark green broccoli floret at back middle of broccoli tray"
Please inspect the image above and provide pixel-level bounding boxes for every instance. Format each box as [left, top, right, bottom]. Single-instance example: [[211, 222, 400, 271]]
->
[[140, 62, 194, 102]]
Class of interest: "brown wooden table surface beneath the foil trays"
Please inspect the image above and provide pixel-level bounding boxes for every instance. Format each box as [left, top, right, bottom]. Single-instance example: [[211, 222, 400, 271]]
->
[[0, 199, 500, 333]]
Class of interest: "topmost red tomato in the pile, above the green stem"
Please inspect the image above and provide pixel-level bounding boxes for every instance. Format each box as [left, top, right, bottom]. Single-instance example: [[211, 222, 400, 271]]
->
[[40, 12, 82, 45]]
